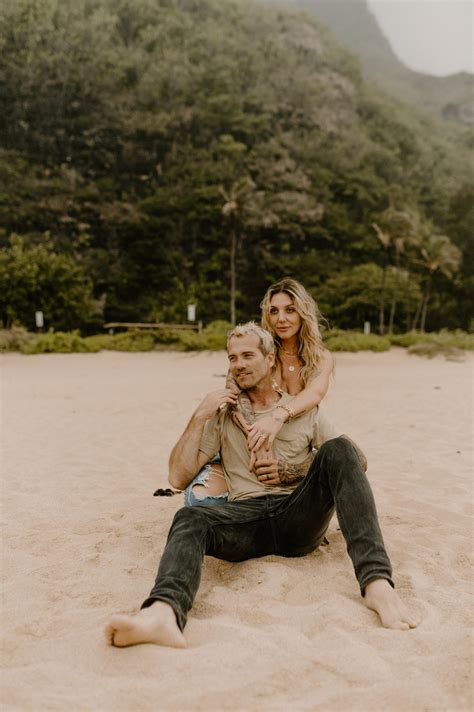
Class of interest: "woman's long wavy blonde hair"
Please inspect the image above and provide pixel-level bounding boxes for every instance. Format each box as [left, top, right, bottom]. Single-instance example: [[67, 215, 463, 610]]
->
[[260, 277, 328, 386]]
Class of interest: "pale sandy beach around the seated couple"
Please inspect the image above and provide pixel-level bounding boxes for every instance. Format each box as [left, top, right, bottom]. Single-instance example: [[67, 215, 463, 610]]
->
[[1, 349, 474, 712]]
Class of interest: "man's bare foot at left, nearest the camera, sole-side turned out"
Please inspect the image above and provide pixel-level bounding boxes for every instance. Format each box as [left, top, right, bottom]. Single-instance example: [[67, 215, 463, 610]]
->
[[105, 601, 186, 648]]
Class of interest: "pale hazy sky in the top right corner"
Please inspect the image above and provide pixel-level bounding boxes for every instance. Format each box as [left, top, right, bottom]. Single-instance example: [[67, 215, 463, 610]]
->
[[368, 0, 474, 76]]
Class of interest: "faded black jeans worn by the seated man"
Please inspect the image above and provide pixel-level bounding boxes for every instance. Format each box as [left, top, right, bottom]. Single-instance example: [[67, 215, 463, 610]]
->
[[142, 437, 393, 630]]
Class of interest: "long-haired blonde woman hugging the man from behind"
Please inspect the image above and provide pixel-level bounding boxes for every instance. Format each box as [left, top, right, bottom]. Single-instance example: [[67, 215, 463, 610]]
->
[[185, 277, 334, 506]]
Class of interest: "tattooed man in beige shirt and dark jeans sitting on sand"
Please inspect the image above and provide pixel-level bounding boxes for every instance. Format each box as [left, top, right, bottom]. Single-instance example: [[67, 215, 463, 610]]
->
[[106, 322, 418, 647]]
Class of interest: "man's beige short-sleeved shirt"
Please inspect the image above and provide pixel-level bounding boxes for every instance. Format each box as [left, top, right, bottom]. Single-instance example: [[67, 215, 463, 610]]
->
[[199, 394, 343, 502]]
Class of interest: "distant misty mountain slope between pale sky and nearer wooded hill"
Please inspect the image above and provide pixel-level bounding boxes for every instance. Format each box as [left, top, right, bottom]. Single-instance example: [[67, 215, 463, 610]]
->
[[292, 0, 474, 124]]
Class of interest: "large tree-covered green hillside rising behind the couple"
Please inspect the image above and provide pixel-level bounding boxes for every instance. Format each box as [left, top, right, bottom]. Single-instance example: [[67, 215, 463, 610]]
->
[[0, 0, 474, 340]]
